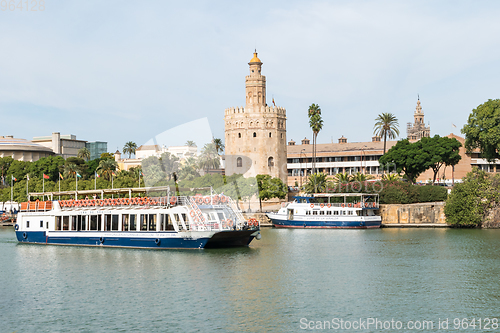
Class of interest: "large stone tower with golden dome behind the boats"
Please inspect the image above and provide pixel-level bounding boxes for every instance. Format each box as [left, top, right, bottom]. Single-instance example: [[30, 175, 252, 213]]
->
[[224, 52, 288, 184]]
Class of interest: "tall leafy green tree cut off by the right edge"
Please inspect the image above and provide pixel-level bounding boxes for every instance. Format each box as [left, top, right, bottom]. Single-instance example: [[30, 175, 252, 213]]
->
[[461, 99, 500, 162]]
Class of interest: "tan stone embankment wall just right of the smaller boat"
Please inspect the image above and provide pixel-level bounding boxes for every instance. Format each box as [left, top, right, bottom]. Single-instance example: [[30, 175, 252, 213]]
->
[[378, 202, 448, 227]]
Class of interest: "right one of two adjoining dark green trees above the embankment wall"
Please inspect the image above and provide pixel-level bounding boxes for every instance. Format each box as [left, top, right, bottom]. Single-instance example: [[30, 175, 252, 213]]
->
[[420, 135, 462, 184]]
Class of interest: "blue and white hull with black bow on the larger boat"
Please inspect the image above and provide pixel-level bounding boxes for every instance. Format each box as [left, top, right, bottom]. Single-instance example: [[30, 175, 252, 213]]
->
[[16, 230, 258, 249]]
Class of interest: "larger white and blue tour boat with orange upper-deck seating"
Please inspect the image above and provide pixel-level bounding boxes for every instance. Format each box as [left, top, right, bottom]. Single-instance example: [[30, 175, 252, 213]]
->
[[15, 187, 260, 249]]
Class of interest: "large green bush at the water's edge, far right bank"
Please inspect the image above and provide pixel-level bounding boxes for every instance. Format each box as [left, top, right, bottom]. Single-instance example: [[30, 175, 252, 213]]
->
[[444, 168, 500, 227]]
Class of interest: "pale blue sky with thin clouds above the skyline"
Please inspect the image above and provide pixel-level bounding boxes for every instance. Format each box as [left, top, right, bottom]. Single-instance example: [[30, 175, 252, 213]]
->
[[0, 0, 500, 152]]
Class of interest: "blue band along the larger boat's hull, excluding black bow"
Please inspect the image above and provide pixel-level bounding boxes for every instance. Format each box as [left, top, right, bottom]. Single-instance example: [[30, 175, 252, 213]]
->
[[16, 231, 209, 249]]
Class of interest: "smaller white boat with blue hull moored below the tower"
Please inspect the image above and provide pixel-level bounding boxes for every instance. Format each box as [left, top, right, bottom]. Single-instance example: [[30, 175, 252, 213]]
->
[[267, 193, 382, 229]]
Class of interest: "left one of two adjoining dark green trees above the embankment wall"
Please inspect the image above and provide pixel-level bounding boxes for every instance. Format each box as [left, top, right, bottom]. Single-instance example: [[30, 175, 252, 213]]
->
[[379, 139, 429, 183]]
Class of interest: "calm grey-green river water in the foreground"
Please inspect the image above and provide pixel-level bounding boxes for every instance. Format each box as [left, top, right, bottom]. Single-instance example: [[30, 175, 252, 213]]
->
[[0, 228, 500, 332]]
